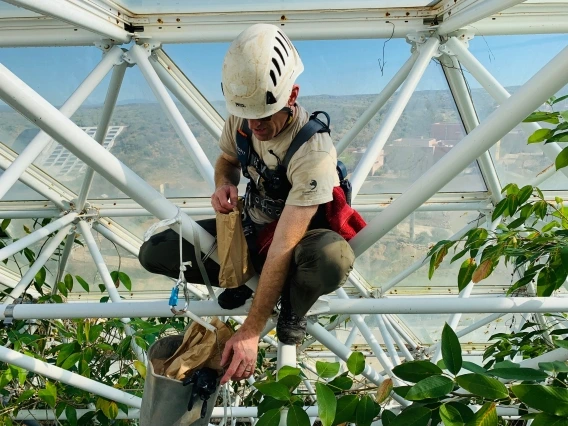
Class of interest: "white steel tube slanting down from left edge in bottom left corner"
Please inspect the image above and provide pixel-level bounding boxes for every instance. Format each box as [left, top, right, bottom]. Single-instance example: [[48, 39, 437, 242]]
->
[[0, 345, 142, 406]]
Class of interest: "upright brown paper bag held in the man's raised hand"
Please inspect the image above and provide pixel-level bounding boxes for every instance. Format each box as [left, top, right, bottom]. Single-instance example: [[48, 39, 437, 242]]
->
[[216, 199, 254, 288]]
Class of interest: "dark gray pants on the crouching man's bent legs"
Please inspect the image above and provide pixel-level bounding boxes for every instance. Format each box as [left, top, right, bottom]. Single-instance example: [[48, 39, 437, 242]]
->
[[138, 219, 355, 316]]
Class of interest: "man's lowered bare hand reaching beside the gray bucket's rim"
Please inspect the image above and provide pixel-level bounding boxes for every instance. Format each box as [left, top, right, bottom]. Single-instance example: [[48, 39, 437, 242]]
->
[[221, 327, 260, 385]]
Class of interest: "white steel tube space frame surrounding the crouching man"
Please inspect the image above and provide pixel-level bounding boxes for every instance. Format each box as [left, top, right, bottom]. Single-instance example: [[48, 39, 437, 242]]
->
[[0, 0, 568, 419]]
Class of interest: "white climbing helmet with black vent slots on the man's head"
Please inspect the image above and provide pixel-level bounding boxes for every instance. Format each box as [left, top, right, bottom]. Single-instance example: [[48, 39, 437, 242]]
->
[[221, 24, 304, 119]]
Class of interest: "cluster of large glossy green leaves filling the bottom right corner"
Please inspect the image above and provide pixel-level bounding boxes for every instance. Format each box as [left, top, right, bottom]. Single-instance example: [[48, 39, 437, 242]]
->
[[388, 324, 568, 426]]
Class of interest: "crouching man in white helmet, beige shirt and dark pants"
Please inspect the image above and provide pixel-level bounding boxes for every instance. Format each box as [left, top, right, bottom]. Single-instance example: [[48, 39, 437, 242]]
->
[[140, 24, 354, 383]]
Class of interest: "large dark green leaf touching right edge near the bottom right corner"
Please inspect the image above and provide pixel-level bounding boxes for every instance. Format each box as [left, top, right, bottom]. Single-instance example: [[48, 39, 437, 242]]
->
[[511, 384, 568, 416]]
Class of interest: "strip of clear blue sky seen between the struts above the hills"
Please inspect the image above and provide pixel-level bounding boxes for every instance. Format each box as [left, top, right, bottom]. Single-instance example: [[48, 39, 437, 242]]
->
[[0, 34, 568, 107]]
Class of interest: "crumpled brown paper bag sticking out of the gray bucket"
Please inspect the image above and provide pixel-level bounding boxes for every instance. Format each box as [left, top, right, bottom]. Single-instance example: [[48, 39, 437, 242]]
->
[[152, 317, 233, 380]]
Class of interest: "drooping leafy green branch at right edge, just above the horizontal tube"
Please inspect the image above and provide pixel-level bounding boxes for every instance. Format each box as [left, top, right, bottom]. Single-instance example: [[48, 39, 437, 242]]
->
[[428, 184, 568, 296]]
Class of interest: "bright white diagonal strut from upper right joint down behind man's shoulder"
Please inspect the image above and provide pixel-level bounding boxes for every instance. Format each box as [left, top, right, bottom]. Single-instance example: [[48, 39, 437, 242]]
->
[[351, 36, 440, 200]]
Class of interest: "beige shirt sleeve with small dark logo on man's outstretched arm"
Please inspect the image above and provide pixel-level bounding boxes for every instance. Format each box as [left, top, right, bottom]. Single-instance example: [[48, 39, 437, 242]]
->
[[286, 142, 337, 206]]
